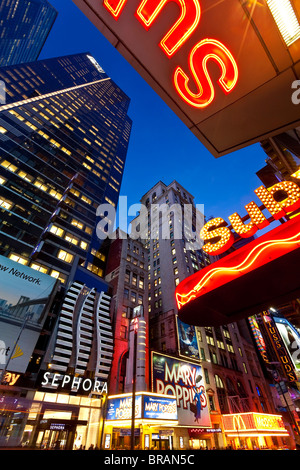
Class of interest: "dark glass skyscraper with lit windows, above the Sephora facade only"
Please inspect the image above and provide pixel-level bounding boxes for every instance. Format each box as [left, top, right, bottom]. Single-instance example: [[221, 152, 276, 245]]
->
[[0, 53, 132, 285]]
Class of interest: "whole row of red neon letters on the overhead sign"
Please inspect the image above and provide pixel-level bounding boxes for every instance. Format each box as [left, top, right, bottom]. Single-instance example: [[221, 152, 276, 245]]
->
[[103, 0, 239, 109]]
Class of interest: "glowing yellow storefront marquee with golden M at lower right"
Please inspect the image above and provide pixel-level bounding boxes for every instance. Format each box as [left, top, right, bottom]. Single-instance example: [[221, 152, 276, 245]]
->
[[222, 412, 290, 450]]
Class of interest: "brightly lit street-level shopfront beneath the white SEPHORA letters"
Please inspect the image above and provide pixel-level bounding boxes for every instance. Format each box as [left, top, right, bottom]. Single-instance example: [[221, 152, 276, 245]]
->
[[0, 391, 103, 450]]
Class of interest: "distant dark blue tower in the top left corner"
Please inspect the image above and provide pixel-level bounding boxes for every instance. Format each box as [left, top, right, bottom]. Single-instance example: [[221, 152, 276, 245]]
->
[[0, 0, 57, 67]]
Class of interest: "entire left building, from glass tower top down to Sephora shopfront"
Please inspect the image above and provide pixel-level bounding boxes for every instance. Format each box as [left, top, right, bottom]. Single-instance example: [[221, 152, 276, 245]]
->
[[0, 53, 132, 450]]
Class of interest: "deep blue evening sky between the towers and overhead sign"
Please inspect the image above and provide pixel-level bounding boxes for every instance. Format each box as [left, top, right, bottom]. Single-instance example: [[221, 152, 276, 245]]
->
[[40, 0, 266, 228]]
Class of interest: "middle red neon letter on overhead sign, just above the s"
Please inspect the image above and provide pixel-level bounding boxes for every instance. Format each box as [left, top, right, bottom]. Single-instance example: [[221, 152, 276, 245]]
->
[[136, 0, 201, 57]]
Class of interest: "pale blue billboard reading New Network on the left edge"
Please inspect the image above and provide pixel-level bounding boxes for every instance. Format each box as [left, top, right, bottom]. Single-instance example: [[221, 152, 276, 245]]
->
[[0, 256, 56, 373]]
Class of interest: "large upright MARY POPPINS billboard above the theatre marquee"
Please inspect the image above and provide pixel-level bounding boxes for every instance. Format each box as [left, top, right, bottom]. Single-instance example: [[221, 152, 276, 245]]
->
[[151, 352, 211, 427]]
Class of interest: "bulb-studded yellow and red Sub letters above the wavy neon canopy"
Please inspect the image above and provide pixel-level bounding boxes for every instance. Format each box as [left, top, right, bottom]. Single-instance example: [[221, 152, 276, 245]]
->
[[200, 171, 300, 255]]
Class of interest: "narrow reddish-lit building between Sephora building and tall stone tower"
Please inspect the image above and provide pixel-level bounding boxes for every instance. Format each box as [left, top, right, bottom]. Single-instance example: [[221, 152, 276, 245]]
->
[[105, 229, 150, 395]]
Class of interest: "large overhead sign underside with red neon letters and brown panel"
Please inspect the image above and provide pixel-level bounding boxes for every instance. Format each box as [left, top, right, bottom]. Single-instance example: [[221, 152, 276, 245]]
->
[[73, 0, 300, 157]]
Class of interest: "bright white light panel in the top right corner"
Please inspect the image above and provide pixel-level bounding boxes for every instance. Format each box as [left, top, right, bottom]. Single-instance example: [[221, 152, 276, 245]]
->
[[267, 0, 300, 46]]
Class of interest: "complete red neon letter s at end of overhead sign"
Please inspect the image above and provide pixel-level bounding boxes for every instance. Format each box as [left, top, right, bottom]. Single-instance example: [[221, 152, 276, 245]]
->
[[174, 39, 238, 108]]
